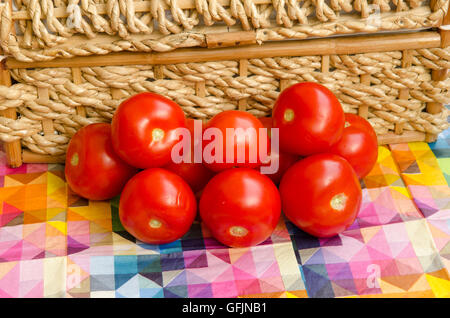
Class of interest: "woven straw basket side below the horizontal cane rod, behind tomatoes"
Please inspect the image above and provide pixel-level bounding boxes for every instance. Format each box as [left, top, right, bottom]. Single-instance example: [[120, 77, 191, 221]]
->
[[0, 48, 450, 155]]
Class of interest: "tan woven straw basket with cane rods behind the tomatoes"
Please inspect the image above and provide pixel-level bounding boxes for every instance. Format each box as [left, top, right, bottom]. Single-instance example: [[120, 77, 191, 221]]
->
[[0, 0, 450, 166]]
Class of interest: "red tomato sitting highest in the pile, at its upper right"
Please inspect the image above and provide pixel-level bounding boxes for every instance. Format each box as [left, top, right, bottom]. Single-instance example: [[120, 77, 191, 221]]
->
[[272, 82, 345, 156]]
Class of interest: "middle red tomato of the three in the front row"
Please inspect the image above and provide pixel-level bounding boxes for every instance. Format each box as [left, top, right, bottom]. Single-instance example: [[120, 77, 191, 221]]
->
[[200, 168, 281, 247]]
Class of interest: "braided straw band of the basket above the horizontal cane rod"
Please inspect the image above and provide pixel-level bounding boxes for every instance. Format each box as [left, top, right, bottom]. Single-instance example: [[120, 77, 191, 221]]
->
[[0, 0, 450, 62]]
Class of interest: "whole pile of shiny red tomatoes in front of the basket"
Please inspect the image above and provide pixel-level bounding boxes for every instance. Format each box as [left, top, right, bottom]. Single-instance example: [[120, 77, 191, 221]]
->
[[65, 82, 378, 247]]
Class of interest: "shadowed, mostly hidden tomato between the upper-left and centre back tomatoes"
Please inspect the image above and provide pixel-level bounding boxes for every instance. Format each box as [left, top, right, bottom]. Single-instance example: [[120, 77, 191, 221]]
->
[[164, 118, 214, 193]]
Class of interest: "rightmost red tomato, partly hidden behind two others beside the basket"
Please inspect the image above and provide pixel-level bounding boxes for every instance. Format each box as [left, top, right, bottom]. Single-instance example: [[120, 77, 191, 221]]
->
[[330, 114, 378, 179]]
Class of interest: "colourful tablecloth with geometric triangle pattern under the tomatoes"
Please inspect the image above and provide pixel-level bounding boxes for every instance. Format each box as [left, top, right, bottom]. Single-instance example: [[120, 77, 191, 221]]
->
[[0, 130, 450, 298]]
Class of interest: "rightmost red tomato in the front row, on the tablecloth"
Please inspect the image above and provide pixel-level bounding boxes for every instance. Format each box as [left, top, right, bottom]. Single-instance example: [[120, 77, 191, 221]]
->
[[280, 153, 362, 237]]
